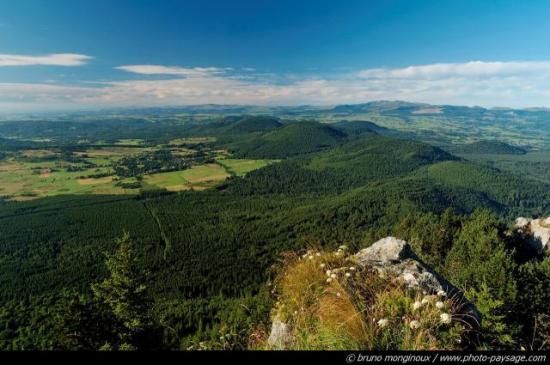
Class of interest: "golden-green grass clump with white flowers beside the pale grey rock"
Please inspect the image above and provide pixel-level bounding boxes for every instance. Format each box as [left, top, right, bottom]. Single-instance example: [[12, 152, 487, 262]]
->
[[266, 246, 468, 350]]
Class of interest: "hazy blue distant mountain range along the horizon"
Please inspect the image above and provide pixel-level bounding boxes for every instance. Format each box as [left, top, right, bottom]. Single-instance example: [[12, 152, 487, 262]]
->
[[2, 101, 550, 150]]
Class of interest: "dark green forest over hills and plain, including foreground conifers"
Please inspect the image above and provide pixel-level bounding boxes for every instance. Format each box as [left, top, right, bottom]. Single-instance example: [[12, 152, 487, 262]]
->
[[0, 116, 550, 350]]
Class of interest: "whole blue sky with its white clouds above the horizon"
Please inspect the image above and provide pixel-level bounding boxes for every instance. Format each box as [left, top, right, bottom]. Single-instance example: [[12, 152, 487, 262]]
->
[[0, 0, 550, 113]]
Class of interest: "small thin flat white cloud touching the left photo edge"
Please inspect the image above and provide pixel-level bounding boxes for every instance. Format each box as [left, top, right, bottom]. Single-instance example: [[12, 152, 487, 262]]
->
[[0, 53, 92, 67]]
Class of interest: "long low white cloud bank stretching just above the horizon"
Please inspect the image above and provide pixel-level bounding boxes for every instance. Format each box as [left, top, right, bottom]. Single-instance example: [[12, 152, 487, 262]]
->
[[0, 57, 550, 110]]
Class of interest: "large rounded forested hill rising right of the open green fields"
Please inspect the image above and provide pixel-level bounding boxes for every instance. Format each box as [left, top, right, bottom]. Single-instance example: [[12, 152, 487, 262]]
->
[[229, 135, 550, 219]]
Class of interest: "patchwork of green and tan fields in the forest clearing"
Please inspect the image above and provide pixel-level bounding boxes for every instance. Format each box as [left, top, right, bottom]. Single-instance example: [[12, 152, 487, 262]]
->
[[0, 146, 270, 201]]
